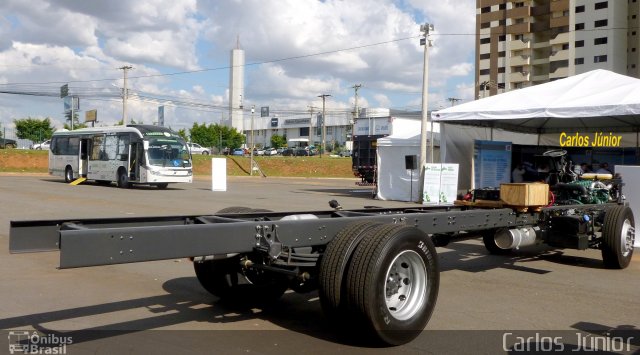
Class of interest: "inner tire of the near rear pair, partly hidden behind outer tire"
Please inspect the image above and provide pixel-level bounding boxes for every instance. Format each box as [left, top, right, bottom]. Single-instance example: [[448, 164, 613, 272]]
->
[[318, 222, 379, 324]]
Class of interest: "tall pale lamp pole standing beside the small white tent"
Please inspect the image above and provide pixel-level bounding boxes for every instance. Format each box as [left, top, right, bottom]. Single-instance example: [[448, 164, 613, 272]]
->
[[418, 23, 433, 201]]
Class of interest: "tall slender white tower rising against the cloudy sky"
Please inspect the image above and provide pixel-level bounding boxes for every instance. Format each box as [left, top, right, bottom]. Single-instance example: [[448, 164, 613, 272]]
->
[[228, 39, 244, 133]]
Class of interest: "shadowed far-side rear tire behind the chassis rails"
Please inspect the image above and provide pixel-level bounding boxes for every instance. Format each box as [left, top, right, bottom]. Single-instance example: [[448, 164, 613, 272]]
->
[[193, 207, 289, 302]]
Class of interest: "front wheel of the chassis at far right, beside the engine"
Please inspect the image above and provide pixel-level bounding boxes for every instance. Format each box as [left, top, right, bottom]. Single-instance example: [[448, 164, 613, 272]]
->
[[602, 206, 635, 269]]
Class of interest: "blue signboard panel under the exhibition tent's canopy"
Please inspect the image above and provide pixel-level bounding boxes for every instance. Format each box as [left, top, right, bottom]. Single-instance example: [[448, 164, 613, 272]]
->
[[473, 140, 511, 188]]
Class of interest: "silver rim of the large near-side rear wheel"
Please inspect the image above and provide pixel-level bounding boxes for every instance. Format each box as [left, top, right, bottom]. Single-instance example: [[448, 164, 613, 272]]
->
[[384, 250, 429, 320]]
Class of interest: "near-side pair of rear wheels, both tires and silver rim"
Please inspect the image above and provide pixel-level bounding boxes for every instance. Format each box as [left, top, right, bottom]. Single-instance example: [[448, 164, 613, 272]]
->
[[319, 222, 439, 345]]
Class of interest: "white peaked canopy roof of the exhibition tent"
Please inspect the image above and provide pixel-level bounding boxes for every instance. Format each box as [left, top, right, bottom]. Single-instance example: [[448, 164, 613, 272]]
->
[[431, 69, 640, 134]]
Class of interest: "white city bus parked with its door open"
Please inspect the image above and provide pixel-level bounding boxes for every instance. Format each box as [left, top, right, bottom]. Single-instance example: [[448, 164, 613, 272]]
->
[[49, 125, 193, 189]]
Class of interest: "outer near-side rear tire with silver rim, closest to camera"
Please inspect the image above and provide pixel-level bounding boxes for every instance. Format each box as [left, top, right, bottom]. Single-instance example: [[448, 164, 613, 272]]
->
[[346, 225, 440, 345]]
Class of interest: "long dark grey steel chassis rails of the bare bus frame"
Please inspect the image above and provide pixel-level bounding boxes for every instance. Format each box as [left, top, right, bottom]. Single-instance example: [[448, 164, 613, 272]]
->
[[9, 207, 539, 268]]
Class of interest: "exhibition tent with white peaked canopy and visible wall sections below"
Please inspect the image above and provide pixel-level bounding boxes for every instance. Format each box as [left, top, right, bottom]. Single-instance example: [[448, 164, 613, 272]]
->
[[431, 69, 640, 189]]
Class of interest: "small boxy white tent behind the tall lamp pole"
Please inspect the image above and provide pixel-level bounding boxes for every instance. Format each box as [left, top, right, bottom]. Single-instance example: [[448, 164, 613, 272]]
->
[[376, 132, 420, 201]]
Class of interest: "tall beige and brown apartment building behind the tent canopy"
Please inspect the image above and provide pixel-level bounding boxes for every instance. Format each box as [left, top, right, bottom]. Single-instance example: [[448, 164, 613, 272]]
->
[[475, 0, 640, 98]]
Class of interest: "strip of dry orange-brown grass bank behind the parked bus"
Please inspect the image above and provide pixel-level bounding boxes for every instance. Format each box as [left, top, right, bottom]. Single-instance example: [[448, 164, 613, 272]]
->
[[0, 149, 353, 178]]
